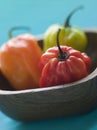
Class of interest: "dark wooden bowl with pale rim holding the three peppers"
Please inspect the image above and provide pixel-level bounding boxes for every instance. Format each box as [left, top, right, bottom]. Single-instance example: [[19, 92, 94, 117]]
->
[[0, 30, 97, 121]]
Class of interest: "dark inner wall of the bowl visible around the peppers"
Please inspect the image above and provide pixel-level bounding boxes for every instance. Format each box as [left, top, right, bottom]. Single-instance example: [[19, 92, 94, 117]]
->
[[0, 30, 97, 91]]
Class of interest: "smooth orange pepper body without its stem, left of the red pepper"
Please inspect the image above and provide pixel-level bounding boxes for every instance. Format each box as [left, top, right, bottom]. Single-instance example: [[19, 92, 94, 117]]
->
[[0, 34, 42, 90]]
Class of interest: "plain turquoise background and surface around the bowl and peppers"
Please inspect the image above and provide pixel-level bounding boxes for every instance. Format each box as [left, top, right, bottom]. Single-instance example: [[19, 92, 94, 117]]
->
[[0, 0, 97, 130]]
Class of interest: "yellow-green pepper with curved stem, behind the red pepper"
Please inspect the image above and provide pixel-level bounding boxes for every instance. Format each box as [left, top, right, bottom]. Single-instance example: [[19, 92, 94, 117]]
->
[[43, 6, 88, 52]]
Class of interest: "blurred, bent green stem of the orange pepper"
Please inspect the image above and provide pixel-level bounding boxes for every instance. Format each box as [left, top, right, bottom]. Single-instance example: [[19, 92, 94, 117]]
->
[[8, 26, 31, 39]]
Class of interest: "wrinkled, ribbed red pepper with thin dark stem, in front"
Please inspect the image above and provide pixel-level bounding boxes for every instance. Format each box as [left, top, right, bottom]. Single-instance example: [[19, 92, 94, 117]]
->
[[39, 29, 91, 88]]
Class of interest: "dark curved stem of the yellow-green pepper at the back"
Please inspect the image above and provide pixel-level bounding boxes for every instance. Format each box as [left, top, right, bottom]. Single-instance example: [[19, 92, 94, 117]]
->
[[64, 6, 83, 27]]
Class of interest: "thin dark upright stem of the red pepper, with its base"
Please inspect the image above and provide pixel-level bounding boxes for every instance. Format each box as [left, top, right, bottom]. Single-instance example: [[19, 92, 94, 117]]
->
[[57, 29, 68, 61]]
